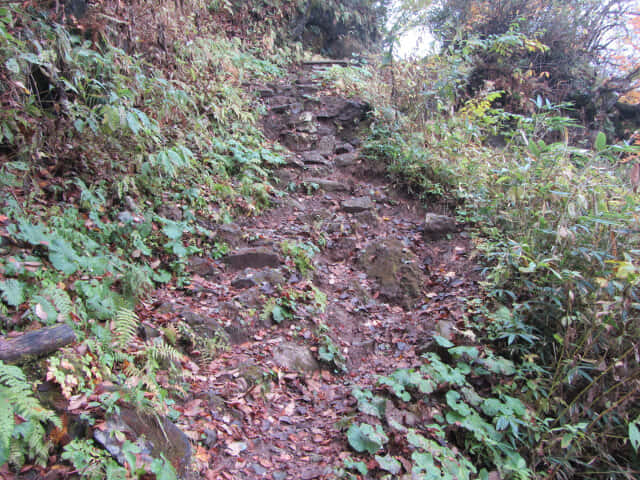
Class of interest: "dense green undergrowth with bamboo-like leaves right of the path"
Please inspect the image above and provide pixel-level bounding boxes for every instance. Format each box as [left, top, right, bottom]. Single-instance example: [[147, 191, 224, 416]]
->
[[328, 32, 640, 478]]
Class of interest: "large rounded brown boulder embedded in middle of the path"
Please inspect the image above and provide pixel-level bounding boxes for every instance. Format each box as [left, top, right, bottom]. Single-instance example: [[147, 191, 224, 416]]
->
[[358, 239, 425, 308]]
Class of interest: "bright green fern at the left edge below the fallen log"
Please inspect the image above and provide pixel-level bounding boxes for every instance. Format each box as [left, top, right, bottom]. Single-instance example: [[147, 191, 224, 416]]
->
[[0, 360, 62, 467]]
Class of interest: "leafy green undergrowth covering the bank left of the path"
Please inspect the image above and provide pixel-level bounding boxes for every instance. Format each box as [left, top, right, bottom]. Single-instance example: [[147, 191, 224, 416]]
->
[[0, 2, 296, 472]]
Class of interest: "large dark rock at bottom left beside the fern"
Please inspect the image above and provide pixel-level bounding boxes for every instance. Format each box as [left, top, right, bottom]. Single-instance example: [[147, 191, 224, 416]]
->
[[93, 407, 196, 479]]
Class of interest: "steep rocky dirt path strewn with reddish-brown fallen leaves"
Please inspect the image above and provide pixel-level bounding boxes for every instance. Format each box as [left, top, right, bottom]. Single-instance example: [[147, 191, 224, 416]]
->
[[150, 65, 478, 480]]
